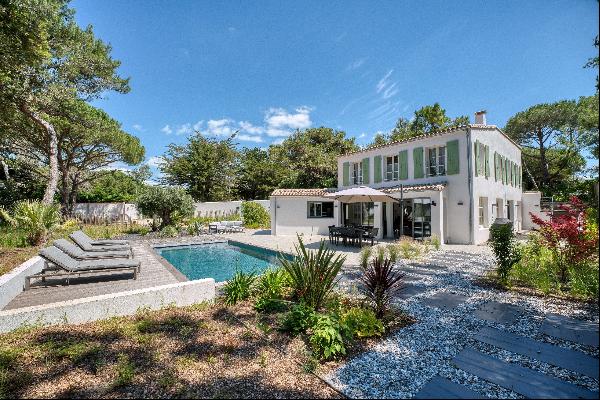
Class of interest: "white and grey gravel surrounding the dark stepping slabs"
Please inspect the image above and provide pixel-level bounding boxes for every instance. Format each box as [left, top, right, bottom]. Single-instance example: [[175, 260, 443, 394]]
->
[[326, 251, 598, 398]]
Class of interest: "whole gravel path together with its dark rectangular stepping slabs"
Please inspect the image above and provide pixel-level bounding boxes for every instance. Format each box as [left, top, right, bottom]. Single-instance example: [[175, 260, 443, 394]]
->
[[326, 251, 599, 398]]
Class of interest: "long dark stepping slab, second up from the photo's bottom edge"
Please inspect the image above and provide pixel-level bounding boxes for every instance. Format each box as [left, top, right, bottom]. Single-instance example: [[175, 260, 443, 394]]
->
[[453, 348, 598, 399]]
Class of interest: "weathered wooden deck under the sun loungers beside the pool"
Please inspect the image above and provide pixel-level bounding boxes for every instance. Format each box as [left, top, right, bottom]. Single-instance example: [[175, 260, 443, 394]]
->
[[3, 241, 187, 310]]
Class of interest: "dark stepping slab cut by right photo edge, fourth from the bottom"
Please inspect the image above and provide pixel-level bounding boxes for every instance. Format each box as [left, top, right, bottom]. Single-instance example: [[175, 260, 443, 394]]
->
[[540, 314, 598, 347]]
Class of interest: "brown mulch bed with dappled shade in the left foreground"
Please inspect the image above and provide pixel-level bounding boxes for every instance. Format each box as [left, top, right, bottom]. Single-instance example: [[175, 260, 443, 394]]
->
[[0, 305, 340, 398]]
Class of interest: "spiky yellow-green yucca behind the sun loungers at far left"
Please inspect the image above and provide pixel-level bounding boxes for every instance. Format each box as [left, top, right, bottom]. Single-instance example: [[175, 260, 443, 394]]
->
[[0, 200, 60, 246]]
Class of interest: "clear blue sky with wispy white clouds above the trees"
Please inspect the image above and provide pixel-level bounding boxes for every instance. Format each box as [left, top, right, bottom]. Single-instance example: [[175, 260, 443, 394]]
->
[[71, 0, 599, 175]]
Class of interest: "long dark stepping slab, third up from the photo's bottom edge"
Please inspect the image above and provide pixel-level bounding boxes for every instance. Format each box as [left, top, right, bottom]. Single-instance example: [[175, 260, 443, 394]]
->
[[474, 327, 599, 380]]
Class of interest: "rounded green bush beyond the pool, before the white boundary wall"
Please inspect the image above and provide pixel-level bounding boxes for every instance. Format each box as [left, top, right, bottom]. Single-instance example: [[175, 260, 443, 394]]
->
[[136, 186, 194, 229]]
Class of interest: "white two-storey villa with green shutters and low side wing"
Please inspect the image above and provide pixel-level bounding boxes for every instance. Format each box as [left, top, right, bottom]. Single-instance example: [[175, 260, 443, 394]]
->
[[270, 111, 540, 244]]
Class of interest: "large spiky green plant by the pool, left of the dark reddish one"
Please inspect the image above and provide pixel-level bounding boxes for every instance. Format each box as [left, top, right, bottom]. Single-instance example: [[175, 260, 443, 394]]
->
[[279, 236, 346, 310]]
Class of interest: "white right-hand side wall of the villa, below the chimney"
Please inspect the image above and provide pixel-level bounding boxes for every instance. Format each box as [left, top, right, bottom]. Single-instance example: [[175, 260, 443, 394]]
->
[[471, 128, 523, 244]]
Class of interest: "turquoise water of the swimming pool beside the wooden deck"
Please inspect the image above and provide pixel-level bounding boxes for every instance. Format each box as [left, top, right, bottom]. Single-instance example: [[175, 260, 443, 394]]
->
[[155, 241, 291, 282]]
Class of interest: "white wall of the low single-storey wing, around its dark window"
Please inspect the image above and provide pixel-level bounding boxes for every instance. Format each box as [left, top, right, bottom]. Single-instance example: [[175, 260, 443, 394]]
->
[[270, 196, 340, 236]]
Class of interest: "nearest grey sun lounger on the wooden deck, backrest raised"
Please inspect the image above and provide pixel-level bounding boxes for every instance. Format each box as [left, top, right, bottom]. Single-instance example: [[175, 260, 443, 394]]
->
[[25, 246, 140, 290]]
